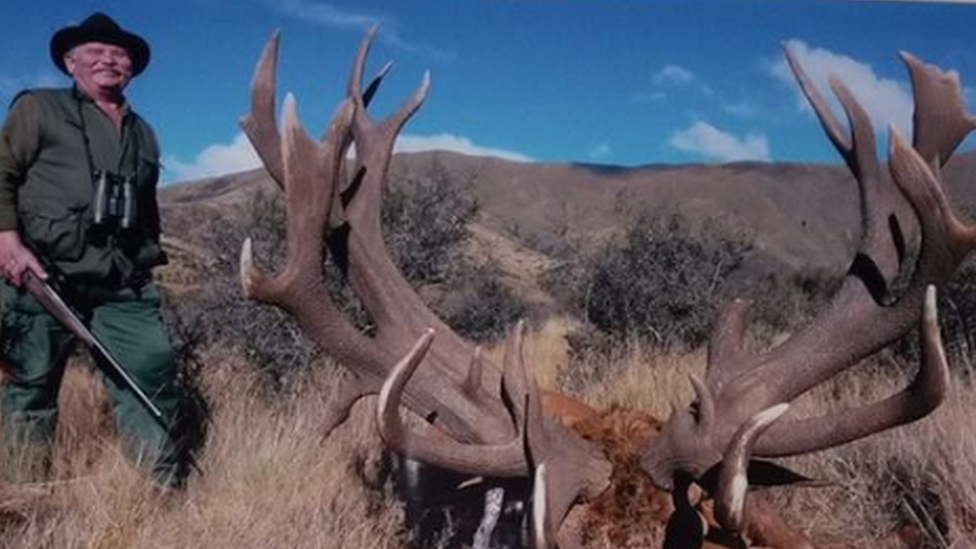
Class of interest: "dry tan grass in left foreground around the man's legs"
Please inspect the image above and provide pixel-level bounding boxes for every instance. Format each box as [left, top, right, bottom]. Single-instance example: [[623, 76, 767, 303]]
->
[[0, 352, 402, 549]]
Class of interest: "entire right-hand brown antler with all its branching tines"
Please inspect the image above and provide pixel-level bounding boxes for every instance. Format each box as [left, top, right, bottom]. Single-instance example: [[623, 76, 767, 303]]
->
[[642, 48, 976, 529]]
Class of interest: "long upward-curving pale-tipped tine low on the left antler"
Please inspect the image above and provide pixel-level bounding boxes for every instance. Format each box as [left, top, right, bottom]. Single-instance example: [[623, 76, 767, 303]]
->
[[376, 330, 528, 477]]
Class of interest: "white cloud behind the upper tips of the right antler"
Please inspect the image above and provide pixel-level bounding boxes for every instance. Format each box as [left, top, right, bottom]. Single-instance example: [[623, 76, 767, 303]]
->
[[770, 40, 912, 136]]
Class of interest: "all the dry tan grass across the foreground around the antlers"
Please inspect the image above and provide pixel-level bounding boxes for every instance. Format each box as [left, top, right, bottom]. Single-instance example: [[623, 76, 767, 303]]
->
[[0, 321, 976, 549]]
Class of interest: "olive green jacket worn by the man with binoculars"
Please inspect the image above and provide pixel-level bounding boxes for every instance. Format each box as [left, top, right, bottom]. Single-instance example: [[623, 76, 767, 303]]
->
[[0, 88, 166, 287]]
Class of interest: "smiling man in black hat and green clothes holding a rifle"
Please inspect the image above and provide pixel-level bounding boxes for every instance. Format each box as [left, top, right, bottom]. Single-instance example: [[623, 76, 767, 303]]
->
[[0, 13, 185, 487]]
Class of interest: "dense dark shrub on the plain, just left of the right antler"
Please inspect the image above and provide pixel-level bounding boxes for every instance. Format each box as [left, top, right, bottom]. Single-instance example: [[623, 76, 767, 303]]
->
[[573, 212, 752, 347]]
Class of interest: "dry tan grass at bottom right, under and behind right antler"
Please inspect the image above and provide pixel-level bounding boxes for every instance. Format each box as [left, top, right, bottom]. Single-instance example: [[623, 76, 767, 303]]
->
[[778, 358, 976, 548]]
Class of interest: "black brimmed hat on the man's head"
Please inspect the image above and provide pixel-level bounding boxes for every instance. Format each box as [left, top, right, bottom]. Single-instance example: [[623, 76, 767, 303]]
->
[[51, 12, 149, 76]]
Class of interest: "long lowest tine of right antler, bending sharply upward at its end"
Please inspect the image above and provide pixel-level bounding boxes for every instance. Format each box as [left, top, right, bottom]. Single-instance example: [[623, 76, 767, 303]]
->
[[754, 286, 949, 457]]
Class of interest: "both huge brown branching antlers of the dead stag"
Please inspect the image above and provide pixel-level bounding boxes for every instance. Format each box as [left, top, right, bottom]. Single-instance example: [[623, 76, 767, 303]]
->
[[241, 29, 976, 549]]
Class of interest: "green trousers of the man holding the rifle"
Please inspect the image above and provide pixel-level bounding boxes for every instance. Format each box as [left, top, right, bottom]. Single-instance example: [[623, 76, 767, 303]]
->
[[0, 282, 185, 487]]
